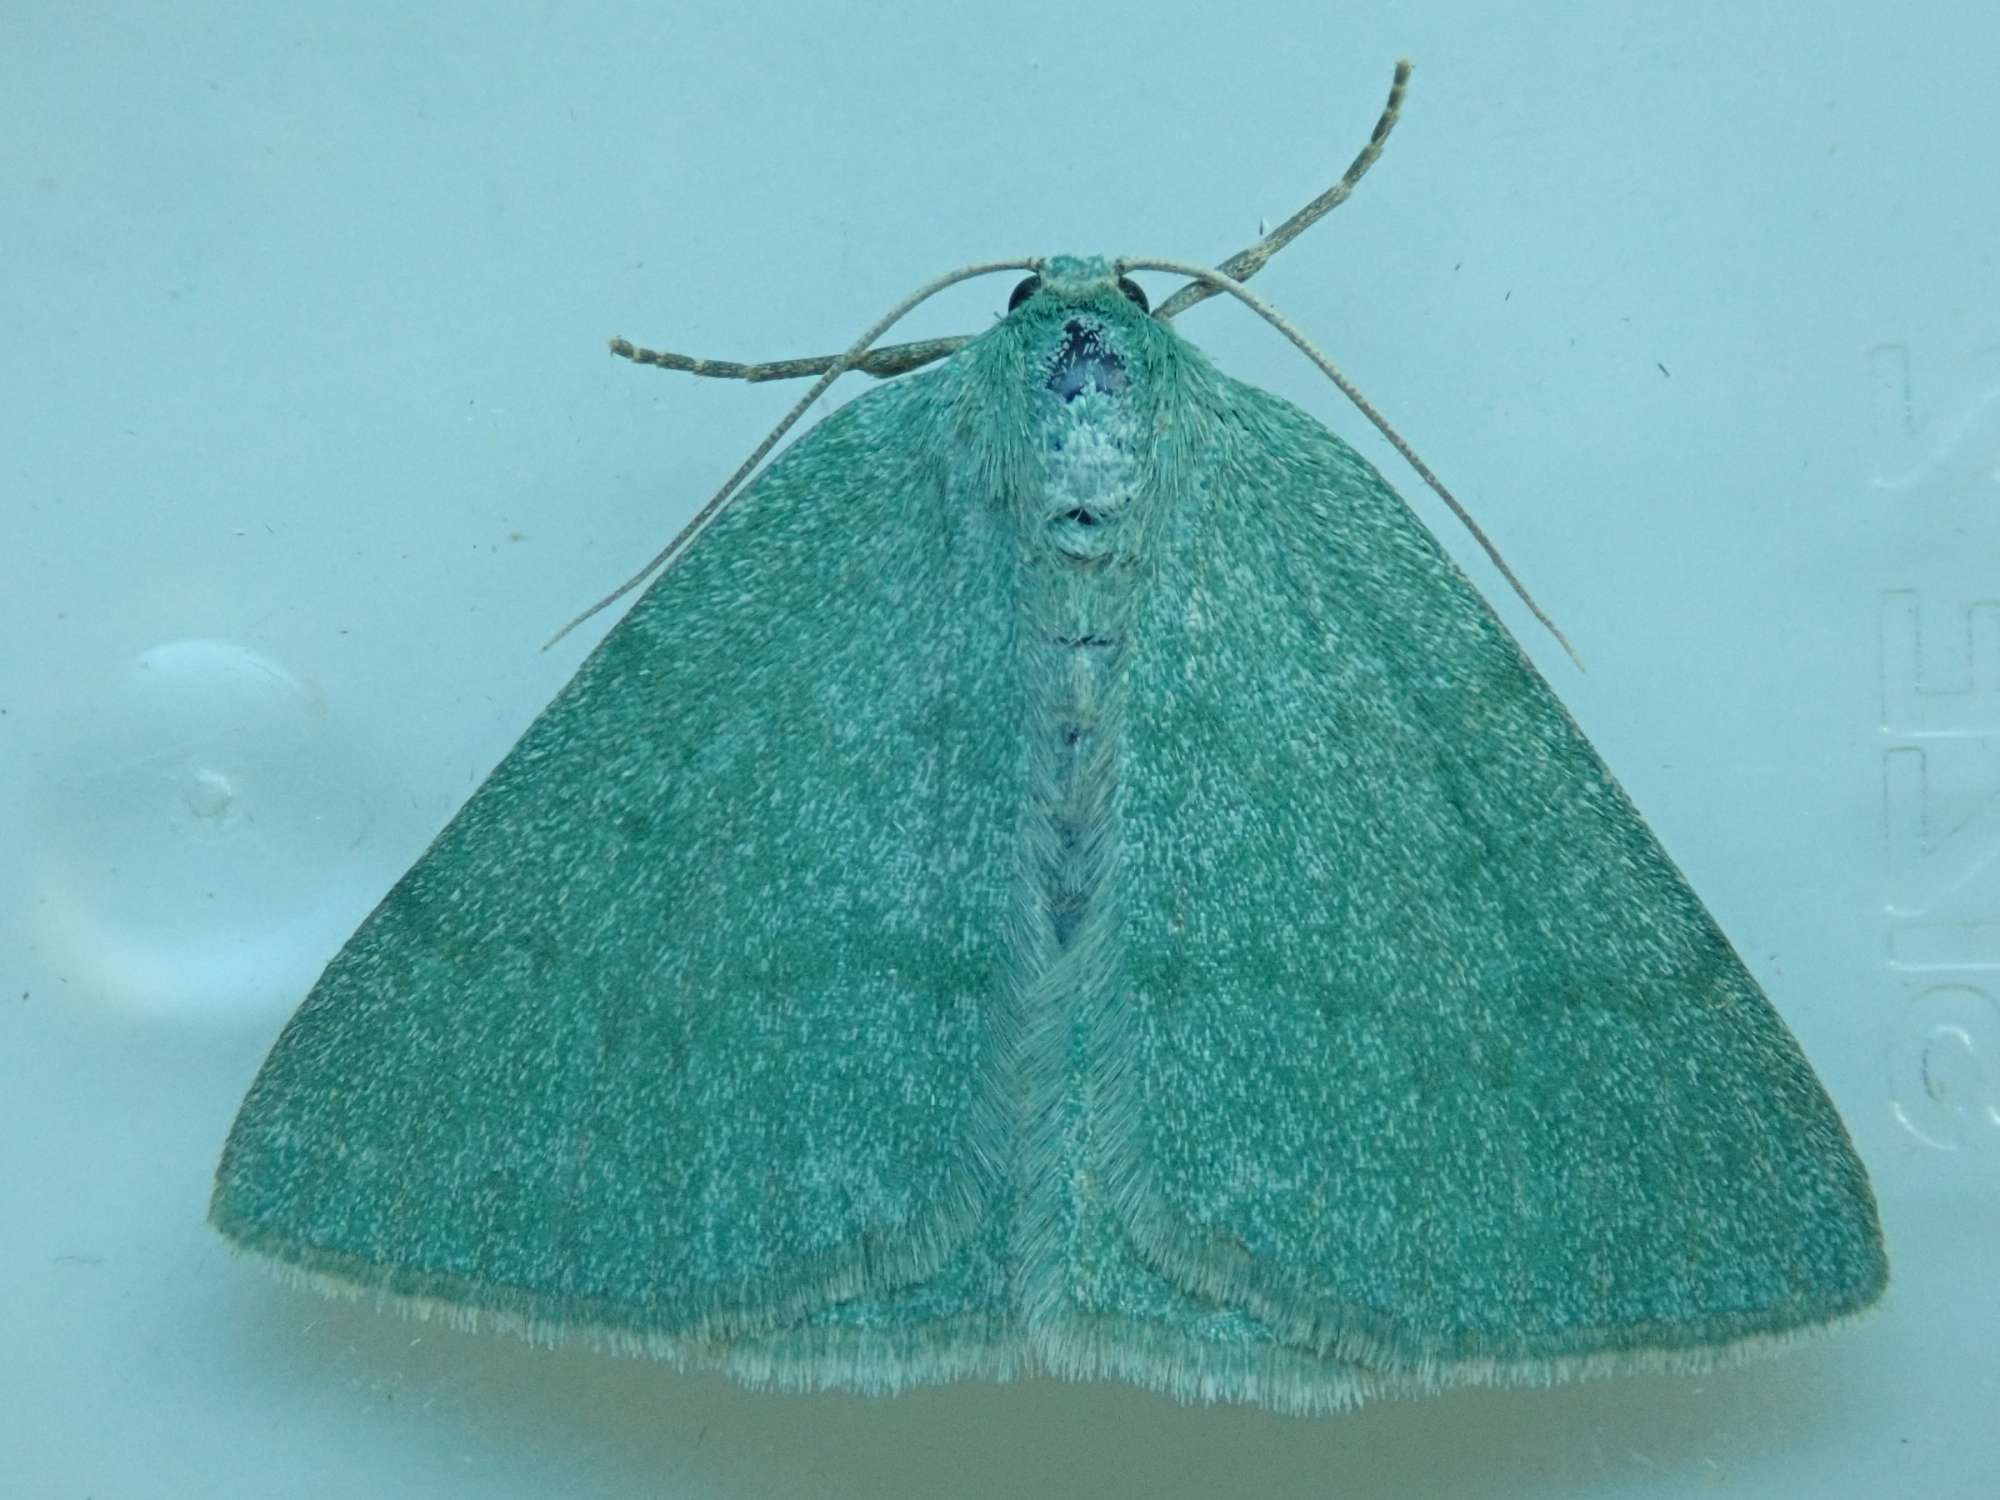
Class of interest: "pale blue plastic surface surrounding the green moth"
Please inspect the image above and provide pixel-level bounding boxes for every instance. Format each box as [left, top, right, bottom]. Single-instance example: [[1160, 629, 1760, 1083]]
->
[[0, 0, 2000, 1500]]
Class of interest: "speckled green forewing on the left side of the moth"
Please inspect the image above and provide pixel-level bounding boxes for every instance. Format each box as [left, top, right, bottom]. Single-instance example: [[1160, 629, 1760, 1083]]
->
[[212, 372, 1022, 1342]]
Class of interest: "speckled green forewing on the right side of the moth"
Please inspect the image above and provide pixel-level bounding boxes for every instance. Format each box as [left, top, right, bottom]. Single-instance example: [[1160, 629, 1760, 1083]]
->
[[1120, 380, 1886, 1386]]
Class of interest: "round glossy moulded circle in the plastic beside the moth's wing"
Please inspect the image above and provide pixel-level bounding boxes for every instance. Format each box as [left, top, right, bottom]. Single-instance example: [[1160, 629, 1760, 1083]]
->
[[26, 640, 374, 1016]]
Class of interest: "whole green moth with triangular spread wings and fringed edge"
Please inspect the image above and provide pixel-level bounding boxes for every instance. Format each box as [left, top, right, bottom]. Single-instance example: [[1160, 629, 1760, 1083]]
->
[[210, 61, 1886, 1412]]
